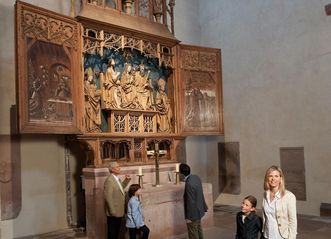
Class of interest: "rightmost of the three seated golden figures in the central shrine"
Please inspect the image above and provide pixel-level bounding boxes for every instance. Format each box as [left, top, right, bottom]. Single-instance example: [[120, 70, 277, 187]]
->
[[135, 63, 152, 110]]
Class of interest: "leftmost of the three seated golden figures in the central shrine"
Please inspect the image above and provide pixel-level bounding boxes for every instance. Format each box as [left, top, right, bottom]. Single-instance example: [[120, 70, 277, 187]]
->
[[103, 59, 121, 109]]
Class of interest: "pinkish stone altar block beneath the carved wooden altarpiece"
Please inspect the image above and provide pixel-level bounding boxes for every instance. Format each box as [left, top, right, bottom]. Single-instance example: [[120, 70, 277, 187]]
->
[[83, 164, 213, 239]]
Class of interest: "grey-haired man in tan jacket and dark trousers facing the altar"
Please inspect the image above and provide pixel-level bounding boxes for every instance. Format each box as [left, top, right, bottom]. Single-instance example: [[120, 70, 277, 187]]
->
[[104, 162, 131, 239]]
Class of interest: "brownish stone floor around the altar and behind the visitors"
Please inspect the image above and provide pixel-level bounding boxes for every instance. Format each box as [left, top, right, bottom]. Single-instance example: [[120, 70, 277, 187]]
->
[[26, 205, 331, 239]]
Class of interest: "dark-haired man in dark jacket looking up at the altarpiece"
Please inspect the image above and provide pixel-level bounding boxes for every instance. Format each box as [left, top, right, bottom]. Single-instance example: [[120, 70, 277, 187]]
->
[[179, 163, 208, 239]]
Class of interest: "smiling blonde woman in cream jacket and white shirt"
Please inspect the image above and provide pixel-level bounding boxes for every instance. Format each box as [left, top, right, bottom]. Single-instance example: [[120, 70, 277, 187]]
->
[[262, 166, 297, 239]]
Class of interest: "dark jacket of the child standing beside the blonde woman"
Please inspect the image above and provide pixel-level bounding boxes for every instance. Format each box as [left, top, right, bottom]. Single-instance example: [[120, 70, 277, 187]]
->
[[236, 212, 263, 239]]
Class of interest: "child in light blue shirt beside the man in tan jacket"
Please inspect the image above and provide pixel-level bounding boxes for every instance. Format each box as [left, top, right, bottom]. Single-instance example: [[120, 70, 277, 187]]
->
[[126, 184, 149, 239]]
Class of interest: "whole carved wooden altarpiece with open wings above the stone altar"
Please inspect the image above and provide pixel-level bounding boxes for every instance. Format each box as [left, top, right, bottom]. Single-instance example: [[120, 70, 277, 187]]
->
[[16, 0, 223, 166]]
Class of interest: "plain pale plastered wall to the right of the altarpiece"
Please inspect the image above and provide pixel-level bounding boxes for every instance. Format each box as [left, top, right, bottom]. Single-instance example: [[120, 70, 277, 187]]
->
[[199, 0, 331, 215]]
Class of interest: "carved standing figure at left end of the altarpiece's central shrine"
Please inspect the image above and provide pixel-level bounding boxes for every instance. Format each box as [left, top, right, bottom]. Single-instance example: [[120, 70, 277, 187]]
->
[[84, 67, 101, 132]]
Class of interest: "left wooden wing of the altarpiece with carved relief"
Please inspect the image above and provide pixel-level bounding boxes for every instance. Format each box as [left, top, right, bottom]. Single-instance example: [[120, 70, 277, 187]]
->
[[16, 2, 82, 133]]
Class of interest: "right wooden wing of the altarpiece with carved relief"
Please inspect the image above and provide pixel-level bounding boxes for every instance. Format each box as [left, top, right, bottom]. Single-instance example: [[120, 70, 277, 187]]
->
[[177, 45, 224, 135]]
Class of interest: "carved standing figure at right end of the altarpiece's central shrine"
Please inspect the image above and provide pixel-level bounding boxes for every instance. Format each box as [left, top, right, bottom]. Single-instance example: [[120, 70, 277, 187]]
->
[[155, 78, 173, 133]]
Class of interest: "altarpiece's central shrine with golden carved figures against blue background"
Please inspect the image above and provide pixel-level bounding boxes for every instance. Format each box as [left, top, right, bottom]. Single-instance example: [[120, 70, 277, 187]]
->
[[83, 23, 175, 135]]
